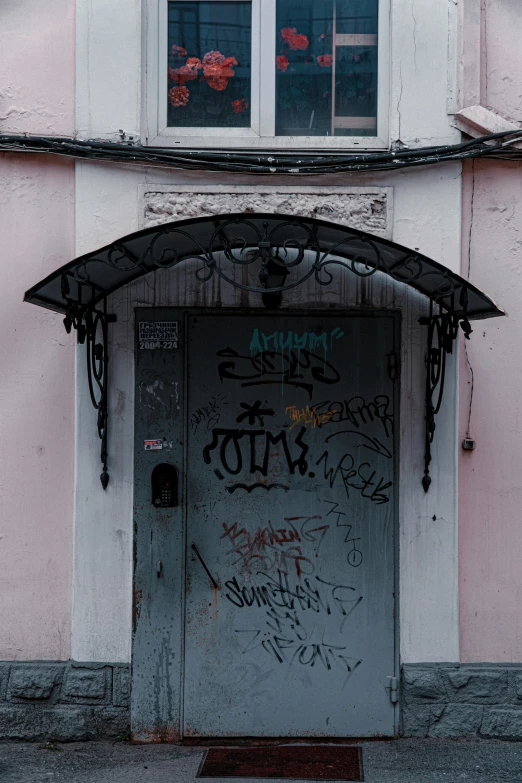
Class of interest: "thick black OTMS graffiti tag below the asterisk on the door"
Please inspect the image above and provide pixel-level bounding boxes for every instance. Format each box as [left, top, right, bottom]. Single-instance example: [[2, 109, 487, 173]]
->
[[203, 427, 309, 492]]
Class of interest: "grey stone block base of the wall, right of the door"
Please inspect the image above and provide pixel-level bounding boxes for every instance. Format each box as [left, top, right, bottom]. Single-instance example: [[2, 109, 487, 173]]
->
[[401, 663, 522, 740]]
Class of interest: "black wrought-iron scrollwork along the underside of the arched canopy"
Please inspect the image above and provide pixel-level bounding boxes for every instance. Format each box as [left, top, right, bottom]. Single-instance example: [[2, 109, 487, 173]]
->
[[67, 214, 474, 316]]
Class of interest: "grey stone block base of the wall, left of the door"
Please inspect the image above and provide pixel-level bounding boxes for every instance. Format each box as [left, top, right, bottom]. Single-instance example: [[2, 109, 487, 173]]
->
[[0, 661, 130, 741]]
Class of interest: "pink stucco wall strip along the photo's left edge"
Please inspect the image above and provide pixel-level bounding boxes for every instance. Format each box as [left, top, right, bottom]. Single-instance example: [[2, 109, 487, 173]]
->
[[0, 0, 74, 660]]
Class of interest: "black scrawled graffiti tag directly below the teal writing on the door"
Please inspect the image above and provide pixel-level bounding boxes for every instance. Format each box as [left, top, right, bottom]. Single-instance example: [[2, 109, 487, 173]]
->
[[216, 348, 341, 399]]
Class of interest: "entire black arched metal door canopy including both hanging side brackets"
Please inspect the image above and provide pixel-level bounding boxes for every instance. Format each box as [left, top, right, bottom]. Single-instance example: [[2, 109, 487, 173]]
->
[[25, 213, 505, 491]]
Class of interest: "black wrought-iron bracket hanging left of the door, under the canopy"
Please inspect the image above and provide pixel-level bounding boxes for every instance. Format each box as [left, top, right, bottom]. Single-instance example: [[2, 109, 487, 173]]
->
[[62, 275, 116, 489]]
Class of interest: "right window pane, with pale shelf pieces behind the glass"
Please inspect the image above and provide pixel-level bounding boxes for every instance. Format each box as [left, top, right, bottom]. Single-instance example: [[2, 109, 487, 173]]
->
[[276, 0, 378, 136]]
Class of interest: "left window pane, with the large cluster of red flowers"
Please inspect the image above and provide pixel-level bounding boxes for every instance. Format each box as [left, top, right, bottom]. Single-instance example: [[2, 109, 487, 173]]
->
[[167, 0, 252, 128]]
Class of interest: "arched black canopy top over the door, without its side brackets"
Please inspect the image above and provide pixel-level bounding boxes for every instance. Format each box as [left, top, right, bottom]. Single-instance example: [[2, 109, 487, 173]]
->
[[25, 213, 505, 320]]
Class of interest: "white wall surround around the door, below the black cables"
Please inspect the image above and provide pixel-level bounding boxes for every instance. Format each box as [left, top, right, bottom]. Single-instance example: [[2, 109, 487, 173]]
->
[[72, 162, 461, 663]]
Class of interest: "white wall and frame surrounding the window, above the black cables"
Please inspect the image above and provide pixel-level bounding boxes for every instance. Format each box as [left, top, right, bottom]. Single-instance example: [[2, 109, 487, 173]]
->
[[76, 0, 460, 151]]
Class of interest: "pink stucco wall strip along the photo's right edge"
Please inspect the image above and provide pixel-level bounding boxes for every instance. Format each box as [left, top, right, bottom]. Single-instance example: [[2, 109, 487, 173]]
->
[[459, 0, 522, 661]]
